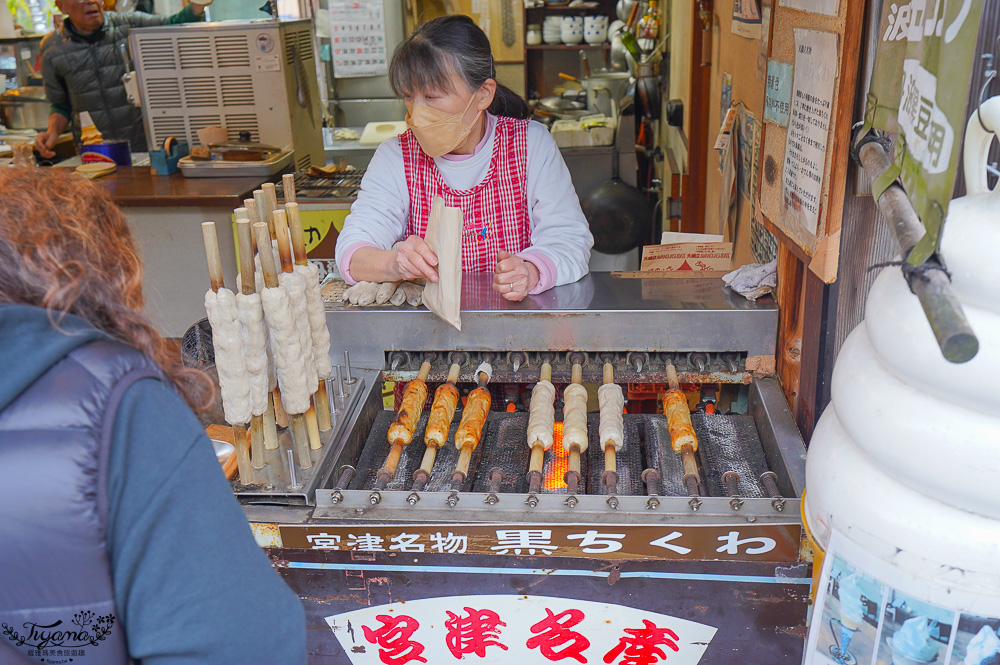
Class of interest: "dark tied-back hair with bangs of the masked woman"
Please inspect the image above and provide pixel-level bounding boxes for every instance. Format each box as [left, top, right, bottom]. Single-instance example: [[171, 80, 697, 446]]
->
[[389, 15, 529, 118]]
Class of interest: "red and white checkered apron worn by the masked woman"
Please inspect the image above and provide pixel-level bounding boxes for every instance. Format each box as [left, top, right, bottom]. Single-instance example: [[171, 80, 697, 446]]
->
[[399, 116, 531, 272]]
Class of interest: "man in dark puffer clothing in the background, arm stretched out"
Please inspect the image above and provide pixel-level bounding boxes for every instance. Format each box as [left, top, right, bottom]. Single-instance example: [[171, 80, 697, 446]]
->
[[35, 0, 212, 158]]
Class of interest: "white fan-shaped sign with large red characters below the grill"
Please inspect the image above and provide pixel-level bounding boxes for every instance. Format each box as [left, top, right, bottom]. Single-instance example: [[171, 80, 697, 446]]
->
[[326, 594, 716, 665]]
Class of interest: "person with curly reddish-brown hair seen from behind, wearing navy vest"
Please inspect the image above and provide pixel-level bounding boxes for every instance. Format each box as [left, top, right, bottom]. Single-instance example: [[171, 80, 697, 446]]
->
[[0, 169, 305, 665]]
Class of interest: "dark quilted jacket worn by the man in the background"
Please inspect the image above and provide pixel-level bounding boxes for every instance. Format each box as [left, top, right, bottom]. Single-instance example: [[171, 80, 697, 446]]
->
[[41, 5, 204, 152]]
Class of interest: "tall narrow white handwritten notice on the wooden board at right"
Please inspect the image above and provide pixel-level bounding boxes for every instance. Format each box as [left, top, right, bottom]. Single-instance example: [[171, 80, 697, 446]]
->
[[782, 28, 837, 235]]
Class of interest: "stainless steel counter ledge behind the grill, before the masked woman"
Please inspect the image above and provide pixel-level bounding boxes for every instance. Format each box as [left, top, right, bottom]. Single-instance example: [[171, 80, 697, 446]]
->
[[327, 273, 778, 369]]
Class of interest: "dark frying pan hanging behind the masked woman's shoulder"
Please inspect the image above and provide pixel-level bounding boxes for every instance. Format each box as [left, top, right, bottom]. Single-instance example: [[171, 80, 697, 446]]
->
[[583, 109, 653, 254]]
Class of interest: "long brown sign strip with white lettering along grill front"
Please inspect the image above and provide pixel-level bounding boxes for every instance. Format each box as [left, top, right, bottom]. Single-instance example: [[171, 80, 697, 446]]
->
[[278, 523, 802, 562]]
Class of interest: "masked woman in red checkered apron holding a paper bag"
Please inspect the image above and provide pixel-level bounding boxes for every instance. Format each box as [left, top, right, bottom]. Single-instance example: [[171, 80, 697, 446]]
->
[[337, 16, 593, 301]]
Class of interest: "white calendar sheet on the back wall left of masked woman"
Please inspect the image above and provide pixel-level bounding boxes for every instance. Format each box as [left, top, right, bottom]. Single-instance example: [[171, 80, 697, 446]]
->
[[328, 0, 389, 78]]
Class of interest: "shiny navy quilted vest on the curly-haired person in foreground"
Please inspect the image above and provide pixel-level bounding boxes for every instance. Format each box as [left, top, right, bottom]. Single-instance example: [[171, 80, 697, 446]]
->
[[0, 340, 164, 665]]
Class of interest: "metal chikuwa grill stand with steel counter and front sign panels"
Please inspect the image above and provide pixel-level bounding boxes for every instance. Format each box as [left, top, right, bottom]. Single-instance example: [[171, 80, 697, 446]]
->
[[239, 273, 810, 664]]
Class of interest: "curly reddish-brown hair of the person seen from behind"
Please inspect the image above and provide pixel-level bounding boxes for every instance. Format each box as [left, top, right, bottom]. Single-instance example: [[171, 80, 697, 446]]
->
[[0, 168, 213, 411]]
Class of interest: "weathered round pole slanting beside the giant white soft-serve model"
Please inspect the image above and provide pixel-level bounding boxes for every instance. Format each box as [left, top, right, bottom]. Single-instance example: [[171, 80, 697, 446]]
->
[[858, 141, 979, 363]]
